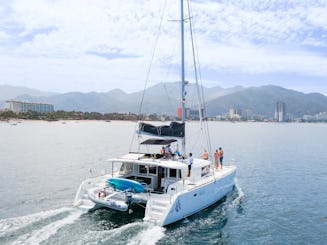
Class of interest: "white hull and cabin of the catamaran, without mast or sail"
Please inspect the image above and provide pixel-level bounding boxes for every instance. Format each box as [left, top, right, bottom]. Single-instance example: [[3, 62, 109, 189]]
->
[[74, 155, 236, 226]]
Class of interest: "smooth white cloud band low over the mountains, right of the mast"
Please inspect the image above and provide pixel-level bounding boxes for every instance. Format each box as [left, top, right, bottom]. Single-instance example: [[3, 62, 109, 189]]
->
[[197, 43, 327, 77]]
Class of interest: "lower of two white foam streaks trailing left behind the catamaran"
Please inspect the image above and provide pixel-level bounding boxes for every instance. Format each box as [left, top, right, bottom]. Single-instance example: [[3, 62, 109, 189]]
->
[[13, 210, 83, 244]]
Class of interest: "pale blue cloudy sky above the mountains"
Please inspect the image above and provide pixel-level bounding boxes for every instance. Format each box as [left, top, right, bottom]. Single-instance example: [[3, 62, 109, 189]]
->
[[0, 0, 327, 95]]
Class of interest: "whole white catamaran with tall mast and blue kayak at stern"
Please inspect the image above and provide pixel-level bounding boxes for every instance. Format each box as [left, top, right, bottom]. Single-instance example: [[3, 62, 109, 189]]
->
[[74, 0, 236, 226]]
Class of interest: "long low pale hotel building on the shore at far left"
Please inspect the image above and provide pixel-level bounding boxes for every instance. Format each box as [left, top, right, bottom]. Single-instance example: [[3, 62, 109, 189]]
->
[[5, 100, 54, 113]]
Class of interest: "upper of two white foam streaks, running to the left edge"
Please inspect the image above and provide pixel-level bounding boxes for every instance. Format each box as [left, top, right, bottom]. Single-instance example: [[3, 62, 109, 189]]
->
[[0, 207, 72, 235]]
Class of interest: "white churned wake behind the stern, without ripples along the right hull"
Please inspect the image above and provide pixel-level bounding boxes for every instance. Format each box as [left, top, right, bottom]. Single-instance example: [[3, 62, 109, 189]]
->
[[0, 207, 165, 245]]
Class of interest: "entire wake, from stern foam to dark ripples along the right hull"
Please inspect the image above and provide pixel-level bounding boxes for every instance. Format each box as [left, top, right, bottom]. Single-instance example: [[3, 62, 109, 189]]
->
[[0, 182, 244, 245]]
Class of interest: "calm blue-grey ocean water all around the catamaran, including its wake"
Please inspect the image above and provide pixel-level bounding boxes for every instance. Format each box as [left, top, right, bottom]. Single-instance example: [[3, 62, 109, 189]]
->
[[0, 121, 327, 244]]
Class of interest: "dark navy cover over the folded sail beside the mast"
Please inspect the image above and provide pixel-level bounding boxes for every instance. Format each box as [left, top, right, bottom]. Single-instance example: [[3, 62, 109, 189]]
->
[[139, 122, 185, 138]]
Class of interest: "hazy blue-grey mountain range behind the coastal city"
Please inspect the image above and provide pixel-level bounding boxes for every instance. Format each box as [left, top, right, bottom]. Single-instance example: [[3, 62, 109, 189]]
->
[[0, 82, 327, 118]]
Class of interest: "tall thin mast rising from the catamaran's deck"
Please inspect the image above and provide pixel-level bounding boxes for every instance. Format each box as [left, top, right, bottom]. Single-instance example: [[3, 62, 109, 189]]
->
[[180, 0, 186, 154]]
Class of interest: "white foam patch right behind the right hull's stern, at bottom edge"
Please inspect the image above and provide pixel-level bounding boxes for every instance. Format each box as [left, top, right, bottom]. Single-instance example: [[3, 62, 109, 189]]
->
[[128, 226, 165, 245]]
